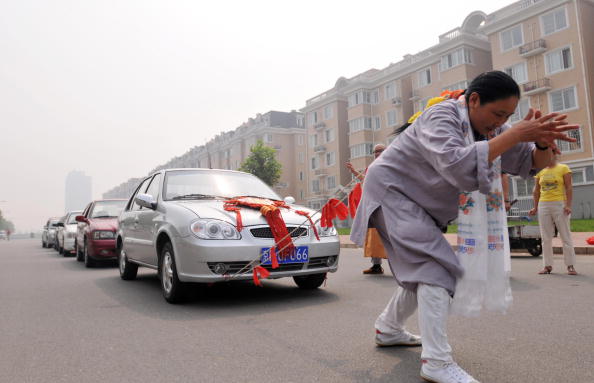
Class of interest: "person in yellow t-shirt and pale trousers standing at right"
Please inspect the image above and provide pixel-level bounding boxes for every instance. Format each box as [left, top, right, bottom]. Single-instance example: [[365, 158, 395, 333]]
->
[[529, 157, 577, 275]]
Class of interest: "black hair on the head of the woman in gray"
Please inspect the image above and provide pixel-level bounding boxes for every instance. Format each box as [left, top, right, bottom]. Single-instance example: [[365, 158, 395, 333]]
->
[[466, 70, 520, 105]]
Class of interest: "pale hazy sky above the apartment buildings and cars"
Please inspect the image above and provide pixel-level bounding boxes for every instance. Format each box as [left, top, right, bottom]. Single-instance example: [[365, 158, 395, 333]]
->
[[0, 0, 511, 231]]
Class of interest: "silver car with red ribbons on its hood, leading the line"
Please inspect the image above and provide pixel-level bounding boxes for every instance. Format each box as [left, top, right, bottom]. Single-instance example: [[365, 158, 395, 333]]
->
[[116, 169, 340, 303]]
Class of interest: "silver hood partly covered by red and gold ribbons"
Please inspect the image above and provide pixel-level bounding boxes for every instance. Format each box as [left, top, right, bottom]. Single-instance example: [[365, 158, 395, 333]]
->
[[173, 200, 319, 226]]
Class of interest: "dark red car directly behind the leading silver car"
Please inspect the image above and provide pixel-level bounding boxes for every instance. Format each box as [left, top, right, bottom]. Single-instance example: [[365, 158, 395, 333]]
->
[[75, 199, 127, 267]]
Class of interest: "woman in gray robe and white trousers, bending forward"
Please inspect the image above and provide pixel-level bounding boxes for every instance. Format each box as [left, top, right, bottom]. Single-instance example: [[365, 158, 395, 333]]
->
[[351, 71, 576, 383]]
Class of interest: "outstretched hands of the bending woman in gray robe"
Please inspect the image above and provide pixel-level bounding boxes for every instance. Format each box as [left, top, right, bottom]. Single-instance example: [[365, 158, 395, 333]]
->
[[510, 108, 579, 148]]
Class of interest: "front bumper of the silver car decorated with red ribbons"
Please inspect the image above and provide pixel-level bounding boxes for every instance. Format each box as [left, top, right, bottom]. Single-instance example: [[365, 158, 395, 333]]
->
[[174, 232, 340, 283]]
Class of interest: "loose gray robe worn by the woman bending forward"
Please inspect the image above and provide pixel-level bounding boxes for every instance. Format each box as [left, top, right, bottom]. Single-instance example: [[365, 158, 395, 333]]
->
[[351, 100, 534, 294]]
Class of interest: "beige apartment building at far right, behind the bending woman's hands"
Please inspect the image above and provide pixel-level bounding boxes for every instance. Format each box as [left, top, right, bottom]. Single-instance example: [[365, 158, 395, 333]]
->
[[481, 0, 594, 218]]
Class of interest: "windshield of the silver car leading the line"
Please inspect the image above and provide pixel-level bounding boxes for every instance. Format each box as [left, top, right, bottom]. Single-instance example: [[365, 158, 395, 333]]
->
[[163, 170, 281, 200]]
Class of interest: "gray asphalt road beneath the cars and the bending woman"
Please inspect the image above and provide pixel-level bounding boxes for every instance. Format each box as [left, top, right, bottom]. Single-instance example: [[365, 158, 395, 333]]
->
[[0, 240, 594, 383]]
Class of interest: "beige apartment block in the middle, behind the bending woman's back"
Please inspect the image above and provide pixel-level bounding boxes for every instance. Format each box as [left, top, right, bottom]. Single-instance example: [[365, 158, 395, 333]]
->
[[301, 12, 491, 209]]
